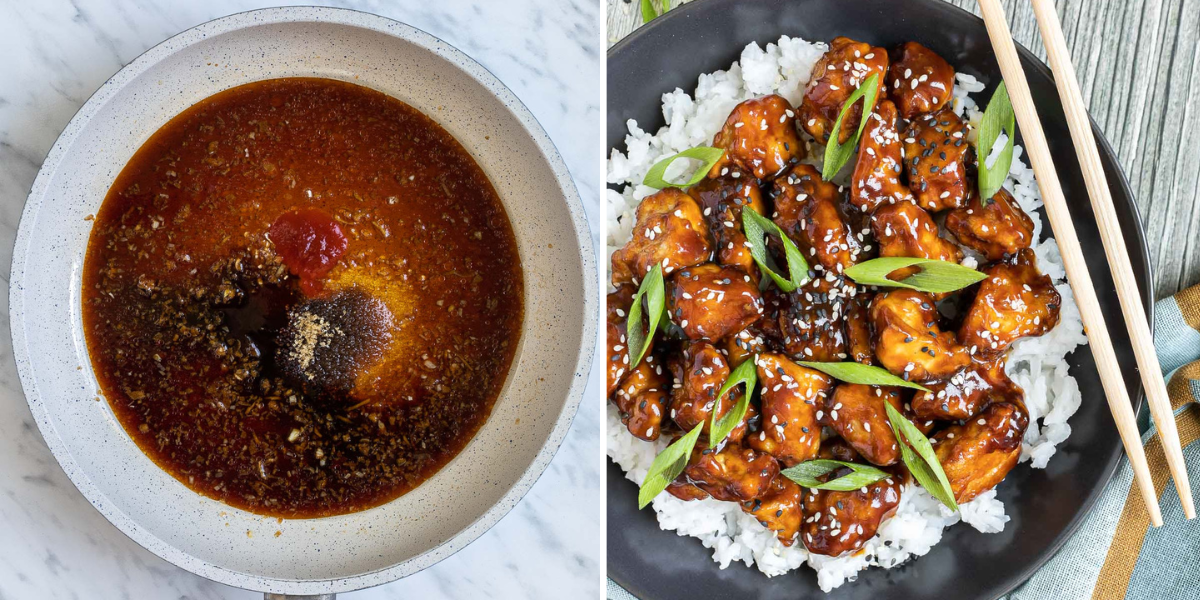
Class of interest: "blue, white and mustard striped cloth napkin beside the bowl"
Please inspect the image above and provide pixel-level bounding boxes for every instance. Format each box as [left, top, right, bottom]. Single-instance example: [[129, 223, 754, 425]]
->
[[608, 286, 1200, 600]]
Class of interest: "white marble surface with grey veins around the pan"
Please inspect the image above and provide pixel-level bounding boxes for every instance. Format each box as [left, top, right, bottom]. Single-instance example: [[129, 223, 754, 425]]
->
[[0, 0, 604, 600]]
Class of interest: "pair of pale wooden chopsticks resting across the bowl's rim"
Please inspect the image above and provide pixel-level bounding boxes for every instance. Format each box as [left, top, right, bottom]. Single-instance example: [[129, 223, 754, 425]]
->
[[978, 0, 1196, 527]]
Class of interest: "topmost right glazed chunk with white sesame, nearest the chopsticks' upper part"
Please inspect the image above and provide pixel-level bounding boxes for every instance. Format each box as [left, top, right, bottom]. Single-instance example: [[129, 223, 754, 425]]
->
[[888, 42, 954, 120]]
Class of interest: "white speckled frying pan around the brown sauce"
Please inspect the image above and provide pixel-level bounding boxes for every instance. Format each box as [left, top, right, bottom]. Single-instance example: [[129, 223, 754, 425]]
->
[[11, 8, 599, 594]]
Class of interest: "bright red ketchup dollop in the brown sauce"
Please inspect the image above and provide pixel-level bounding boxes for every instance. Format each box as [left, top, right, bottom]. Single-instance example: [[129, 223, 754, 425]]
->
[[268, 209, 348, 296]]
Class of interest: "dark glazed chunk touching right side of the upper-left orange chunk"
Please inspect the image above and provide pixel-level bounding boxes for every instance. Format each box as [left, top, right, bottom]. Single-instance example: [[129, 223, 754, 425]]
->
[[688, 176, 767, 283]]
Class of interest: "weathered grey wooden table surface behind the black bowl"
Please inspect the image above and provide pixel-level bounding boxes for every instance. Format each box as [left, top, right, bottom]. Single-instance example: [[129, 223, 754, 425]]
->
[[607, 0, 1200, 298]]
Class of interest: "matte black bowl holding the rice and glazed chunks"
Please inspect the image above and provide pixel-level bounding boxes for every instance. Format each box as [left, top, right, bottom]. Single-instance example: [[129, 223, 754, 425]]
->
[[607, 0, 1153, 600]]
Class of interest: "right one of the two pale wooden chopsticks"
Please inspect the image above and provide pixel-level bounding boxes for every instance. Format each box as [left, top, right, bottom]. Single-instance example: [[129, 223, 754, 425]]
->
[[1032, 0, 1196, 518]]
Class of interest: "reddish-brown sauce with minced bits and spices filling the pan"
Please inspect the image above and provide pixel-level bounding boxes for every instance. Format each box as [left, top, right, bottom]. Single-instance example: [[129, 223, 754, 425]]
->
[[83, 78, 522, 517]]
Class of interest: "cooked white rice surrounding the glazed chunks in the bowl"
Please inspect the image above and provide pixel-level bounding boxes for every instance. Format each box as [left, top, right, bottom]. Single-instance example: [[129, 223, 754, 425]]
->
[[607, 36, 1087, 592]]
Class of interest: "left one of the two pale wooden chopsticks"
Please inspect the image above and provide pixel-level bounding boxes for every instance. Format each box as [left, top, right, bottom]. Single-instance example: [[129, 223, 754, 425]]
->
[[978, 0, 1163, 527]]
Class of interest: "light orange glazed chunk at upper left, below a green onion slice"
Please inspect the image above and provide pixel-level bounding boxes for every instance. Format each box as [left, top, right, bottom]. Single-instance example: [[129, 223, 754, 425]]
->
[[612, 187, 713, 286]]
